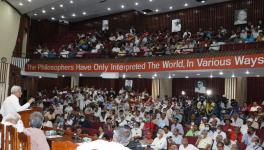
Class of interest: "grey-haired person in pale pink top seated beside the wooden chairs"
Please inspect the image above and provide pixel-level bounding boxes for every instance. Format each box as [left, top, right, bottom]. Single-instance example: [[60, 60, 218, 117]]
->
[[24, 112, 50, 150]]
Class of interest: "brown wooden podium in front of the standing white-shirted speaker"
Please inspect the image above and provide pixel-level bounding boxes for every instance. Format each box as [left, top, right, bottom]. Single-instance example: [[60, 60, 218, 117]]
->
[[18, 107, 42, 128]]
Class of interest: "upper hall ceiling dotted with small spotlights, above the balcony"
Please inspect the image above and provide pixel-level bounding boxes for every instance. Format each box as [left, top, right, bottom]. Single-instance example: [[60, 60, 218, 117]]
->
[[7, 0, 229, 22]]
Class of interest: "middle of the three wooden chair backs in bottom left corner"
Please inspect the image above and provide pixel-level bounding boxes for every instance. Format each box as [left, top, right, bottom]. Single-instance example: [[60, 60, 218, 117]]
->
[[4, 126, 17, 150]]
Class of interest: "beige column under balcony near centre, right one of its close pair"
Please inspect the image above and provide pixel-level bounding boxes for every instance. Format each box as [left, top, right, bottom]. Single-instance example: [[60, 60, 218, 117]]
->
[[159, 78, 172, 97]]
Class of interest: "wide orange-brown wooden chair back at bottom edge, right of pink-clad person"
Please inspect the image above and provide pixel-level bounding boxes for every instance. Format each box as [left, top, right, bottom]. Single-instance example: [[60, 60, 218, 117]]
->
[[51, 141, 77, 150]]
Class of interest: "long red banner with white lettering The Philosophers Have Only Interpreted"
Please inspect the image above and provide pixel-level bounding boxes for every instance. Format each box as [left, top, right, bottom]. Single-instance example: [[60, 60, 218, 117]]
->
[[25, 53, 264, 72]]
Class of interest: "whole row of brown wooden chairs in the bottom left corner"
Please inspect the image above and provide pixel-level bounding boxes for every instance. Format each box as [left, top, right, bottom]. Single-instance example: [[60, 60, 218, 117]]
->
[[0, 124, 31, 150]]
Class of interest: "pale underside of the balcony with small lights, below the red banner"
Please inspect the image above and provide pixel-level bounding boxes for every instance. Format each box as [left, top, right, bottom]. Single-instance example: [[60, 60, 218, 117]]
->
[[28, 68, 264, 79]]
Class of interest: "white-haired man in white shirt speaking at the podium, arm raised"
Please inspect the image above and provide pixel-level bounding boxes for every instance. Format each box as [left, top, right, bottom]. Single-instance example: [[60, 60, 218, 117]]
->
[[1, 85, 35, 118]]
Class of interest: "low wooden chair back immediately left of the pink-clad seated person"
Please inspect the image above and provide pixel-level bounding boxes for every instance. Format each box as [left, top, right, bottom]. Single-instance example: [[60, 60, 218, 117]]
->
[[16, 132, 31, 150]]
